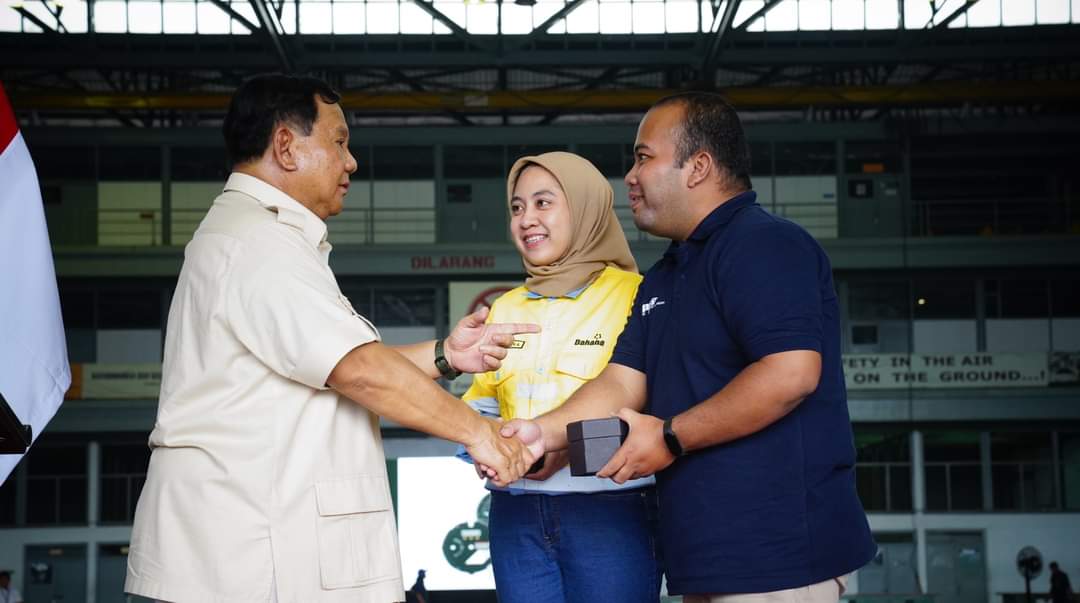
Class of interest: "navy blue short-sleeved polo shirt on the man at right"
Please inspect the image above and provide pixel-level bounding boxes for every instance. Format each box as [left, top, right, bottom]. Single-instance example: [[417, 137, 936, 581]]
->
[[611, 192, 876, 594]]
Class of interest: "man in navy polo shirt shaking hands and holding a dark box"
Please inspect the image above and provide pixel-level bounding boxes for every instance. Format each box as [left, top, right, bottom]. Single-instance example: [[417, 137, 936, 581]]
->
[[503, 93, 876, 603]]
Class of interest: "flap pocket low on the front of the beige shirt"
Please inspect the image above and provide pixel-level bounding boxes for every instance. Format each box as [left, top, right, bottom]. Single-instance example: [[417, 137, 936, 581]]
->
[[315, 475, 401, 589]]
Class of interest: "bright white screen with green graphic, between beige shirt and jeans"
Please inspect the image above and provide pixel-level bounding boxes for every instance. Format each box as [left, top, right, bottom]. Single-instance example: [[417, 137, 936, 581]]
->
[[397, 457, 495, 590]]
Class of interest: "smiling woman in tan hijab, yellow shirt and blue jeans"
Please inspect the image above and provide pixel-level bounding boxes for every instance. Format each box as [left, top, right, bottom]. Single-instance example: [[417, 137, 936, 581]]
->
[[464, 152, 660, 603]]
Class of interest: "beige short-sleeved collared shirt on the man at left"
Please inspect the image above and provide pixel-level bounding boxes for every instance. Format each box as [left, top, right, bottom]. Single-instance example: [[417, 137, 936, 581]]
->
[[124, 174, 405, 603]]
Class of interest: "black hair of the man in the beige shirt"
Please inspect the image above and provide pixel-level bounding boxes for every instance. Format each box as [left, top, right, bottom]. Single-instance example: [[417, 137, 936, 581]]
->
[[221, 73, 341, 166]]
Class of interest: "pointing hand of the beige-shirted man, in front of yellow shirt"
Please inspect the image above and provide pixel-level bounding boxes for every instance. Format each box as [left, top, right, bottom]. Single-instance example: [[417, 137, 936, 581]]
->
[[443, 307, 540, 373]]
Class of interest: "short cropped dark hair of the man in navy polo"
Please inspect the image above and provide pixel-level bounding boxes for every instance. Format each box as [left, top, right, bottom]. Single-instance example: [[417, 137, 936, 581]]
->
[[652, 92, 752, 190]]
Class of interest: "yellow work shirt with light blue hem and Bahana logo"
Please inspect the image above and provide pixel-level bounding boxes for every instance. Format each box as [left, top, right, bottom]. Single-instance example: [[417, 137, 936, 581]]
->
[[462, 267, 653, 492]]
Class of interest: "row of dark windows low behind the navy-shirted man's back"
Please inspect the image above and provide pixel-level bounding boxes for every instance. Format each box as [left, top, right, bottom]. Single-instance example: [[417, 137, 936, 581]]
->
[[855, 430, 1080, 512]]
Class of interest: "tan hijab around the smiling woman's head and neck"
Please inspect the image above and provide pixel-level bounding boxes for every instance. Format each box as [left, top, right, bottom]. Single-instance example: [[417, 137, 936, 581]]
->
[[507, 151, 637, 297]]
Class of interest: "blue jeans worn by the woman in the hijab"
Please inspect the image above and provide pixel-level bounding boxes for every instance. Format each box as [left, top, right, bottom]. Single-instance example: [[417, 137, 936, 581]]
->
[[490, 487, 661, 603]]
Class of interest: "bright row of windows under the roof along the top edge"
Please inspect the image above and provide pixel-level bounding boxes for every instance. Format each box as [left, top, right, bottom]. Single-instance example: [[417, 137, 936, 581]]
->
[[0, 0, 1080, 35]]
